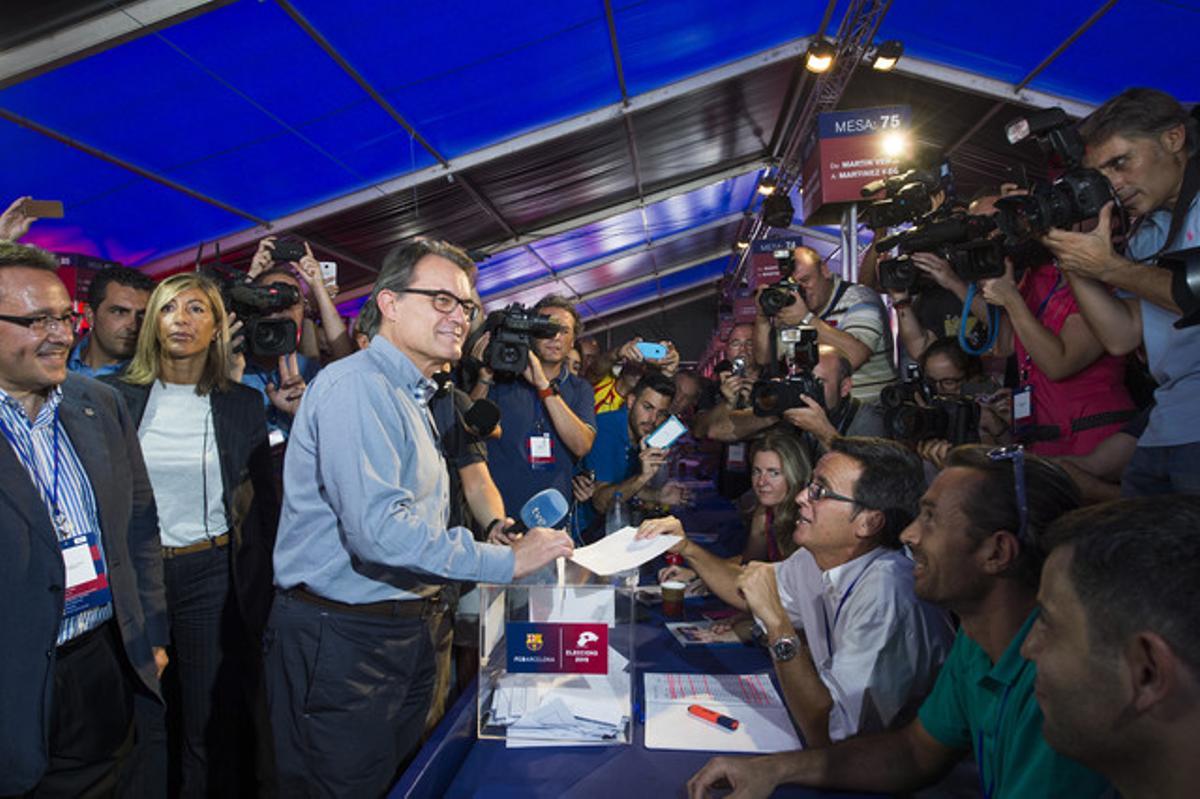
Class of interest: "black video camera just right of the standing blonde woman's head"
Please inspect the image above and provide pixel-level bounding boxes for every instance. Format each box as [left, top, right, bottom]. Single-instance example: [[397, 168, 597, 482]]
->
[[206, 264, 300, 358]]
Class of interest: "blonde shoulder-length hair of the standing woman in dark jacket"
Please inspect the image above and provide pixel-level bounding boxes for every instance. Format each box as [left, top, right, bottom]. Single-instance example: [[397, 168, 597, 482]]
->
[[122, 272, 232, 396]]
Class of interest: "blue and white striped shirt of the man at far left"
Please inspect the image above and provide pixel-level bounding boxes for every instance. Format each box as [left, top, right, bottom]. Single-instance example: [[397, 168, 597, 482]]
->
[[0, 386, 113, 644]]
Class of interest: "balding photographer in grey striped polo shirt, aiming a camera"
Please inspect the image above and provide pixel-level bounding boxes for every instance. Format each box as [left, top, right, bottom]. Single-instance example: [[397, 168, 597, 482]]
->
[[755, 246, 896, 400]]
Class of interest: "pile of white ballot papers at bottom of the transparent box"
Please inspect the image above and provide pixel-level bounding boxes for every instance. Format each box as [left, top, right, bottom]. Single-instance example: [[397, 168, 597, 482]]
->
[[491, 647, 630, 747]]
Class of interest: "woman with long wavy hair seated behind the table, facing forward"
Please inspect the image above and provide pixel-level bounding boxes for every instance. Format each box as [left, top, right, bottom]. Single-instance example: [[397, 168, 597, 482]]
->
[[659, 429, 812, 588]]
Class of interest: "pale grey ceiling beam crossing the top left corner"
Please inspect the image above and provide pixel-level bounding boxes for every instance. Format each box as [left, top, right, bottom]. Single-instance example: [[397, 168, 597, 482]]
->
[[0, 0, 234, 89]]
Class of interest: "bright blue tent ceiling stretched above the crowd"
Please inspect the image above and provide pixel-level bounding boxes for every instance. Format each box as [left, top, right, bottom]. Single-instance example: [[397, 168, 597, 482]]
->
[[0, 0, 1200, 326]]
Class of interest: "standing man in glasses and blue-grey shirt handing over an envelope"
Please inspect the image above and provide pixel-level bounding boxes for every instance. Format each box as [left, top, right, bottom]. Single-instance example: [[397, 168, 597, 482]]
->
[[265, 241, 571, 795]]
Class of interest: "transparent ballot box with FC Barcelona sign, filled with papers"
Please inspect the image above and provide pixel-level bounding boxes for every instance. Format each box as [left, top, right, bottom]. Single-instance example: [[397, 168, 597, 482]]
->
[[478, 572, 634, 746]]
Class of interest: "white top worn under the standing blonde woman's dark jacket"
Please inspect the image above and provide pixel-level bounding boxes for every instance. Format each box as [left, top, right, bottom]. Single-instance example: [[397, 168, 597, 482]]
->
[[138, 380, 229, 547]]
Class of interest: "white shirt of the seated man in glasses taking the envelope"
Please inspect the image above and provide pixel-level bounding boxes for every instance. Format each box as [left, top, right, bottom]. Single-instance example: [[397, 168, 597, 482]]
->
[[775, 548, 954, 740]]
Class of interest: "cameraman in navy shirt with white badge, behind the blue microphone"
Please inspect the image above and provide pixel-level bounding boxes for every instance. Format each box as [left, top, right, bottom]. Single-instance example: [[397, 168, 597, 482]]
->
[[472, 294, 596, 509]]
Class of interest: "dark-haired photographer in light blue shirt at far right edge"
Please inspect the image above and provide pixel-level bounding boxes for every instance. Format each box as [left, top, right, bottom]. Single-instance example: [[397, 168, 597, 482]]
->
[[1042, 89, 1200, 495]]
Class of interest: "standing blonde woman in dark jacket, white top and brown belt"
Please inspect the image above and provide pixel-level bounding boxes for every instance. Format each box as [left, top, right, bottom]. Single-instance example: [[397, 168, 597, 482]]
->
[[106, 274, 278, 797]]
